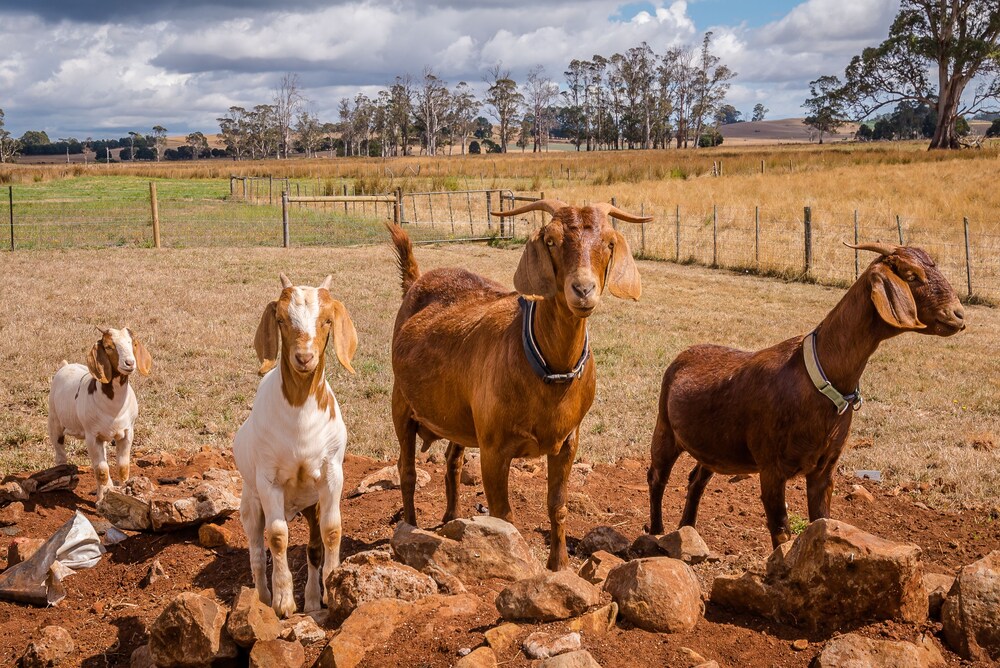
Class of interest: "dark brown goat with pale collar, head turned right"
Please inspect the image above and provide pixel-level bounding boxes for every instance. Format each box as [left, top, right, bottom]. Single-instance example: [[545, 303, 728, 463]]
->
[[648, 244, 965, 547]]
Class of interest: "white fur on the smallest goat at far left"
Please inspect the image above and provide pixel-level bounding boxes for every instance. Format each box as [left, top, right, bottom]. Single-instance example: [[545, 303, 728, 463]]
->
[[49, 360, 139, 502]]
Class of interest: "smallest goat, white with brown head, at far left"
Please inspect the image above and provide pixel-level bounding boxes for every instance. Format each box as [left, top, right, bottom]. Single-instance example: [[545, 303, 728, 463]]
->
[[49, 327, 153, 503]]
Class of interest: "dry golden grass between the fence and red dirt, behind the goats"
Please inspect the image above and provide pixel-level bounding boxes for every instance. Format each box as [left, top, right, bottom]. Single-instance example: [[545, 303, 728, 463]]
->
[[0, 245, 1000, 504]]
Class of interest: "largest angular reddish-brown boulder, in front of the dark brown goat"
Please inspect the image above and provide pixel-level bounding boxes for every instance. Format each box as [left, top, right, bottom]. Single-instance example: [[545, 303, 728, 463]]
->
[[712, 520, 927, 630]]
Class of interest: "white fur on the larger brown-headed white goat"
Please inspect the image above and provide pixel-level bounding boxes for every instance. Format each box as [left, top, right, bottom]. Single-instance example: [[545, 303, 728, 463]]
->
[[233, 362, 347, 617]]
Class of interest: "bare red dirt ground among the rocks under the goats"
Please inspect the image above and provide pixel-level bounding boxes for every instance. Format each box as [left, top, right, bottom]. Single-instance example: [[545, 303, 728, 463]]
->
[[0, 448, 1000, 668]]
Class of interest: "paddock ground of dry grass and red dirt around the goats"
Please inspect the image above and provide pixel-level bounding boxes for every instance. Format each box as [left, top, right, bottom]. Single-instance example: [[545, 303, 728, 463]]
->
[[0, 244, 1000, 666]]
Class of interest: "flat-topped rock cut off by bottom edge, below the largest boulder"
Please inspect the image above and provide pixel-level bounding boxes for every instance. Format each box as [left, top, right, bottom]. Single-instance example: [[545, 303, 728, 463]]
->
[[813, 633, 945, 668]]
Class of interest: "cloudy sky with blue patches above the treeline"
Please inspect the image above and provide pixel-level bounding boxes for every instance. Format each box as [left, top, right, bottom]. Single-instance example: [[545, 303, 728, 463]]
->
[[0, 0, 899, 139]]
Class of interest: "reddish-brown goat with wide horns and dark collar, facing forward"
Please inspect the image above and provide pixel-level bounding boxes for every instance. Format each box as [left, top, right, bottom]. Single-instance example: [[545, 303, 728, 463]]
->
[[389, 199, 650, 570]]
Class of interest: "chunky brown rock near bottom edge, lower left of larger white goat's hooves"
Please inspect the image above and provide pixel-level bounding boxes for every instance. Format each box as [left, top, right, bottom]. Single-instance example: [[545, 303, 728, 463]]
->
[[149, 592, 236, 668]]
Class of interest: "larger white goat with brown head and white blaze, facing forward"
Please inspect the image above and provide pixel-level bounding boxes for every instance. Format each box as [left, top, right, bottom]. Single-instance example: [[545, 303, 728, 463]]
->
[[233, 274, 358, 617]]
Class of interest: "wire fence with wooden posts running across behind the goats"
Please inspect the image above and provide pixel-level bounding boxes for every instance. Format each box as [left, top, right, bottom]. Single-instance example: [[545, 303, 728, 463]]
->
[[0, 177, 1000, 303]]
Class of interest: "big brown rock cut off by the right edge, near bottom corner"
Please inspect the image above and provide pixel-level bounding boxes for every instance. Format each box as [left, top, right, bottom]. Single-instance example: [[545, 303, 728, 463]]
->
[[941, 550, 1000, 661]]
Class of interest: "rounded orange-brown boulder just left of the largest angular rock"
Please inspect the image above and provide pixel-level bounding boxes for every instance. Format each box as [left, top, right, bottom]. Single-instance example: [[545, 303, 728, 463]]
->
[[604, 557, 705, 633]]
